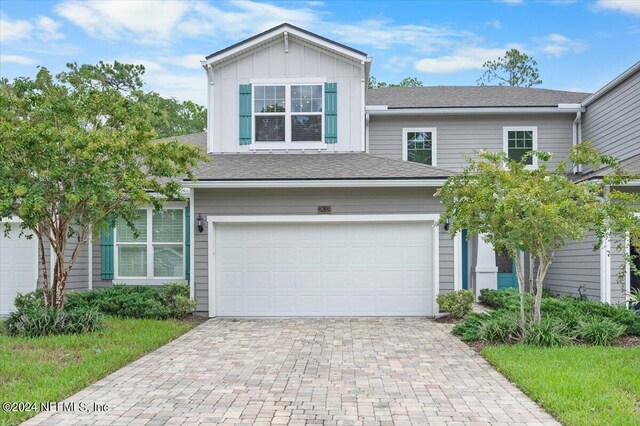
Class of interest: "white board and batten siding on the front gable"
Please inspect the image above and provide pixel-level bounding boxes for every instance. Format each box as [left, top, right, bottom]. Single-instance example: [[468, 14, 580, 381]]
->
[[209, 38, 364, 152]]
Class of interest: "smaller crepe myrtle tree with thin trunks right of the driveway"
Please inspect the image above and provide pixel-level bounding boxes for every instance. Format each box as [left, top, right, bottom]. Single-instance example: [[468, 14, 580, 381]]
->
[[438, 142, 640, 324]]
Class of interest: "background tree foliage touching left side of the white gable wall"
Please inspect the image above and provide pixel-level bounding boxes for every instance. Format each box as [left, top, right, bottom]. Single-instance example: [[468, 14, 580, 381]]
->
[[144, 92, 207, 138]]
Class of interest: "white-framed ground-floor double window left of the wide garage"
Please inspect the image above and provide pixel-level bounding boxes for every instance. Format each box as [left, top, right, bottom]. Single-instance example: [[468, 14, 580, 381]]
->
[[115, 208, 185, 280]]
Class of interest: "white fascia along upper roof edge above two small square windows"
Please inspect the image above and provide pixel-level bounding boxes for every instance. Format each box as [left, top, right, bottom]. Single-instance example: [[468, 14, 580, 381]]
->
[[366, 105, 585, 115]]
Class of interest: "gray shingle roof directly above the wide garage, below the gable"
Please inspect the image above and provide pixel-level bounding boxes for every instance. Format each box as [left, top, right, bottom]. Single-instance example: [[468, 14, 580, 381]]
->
[[188, 153, 453, 181]]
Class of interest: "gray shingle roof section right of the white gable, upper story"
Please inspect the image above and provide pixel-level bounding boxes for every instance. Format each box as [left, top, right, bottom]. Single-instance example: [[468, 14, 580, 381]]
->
[[367, 86, 589, 108]]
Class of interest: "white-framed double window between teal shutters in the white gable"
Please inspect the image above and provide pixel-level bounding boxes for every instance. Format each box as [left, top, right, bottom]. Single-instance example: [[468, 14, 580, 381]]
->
[[253, 84, 324, 146]]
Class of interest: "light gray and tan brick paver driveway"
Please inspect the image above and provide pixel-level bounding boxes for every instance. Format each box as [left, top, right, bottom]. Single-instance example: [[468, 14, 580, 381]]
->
[[23, 319, 557, 425]]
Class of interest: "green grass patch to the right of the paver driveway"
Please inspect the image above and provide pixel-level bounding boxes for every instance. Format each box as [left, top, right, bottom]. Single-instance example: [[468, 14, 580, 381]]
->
[[482, 345, 640, 426]]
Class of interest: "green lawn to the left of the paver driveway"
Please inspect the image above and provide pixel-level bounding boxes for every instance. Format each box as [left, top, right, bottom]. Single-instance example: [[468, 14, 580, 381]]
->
[[0, 318, 192, 425]]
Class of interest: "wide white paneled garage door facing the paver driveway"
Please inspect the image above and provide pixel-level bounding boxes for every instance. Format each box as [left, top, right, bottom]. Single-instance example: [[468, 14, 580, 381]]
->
[[215, 222, 433, 316]]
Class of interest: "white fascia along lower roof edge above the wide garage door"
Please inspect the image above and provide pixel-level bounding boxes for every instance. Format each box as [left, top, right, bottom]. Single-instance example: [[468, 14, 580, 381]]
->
[[184, 179, 446, 188]]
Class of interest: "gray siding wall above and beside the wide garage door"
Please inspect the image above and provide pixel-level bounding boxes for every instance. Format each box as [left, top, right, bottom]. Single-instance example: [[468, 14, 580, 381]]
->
[[192, 188, 453, 313]]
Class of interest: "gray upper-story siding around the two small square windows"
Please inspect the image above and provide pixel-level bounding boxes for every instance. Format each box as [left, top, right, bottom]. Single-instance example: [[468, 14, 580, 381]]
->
[[368, 114, 575, 171]]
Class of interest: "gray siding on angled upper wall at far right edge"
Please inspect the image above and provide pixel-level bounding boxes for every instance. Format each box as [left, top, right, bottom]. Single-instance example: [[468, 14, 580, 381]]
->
[[582, 71, 640, 160]]
